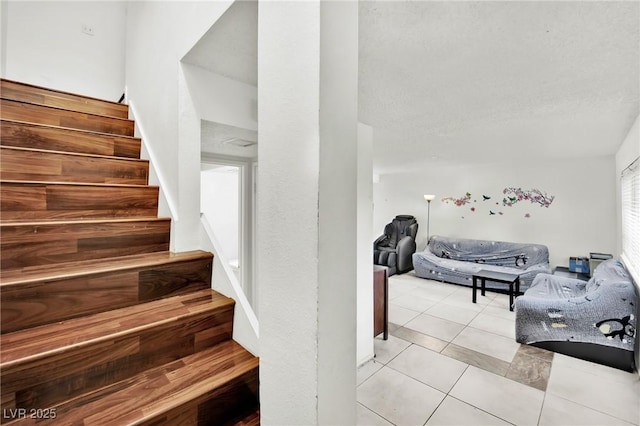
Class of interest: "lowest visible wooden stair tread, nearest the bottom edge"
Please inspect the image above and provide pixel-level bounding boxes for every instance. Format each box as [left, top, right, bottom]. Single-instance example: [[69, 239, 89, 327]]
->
[[16, 341, 259, 425]]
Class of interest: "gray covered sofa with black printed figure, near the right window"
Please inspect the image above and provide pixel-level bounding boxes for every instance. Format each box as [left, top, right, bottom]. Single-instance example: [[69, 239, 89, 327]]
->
[[515, 259, 638, 371]]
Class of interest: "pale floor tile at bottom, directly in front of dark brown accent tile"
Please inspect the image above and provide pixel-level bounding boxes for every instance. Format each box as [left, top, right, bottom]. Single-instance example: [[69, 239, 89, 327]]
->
[[450, 366, 544, 425]]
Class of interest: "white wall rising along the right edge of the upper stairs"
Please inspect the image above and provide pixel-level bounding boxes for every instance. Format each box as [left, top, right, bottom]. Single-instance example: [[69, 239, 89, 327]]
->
[[126, 1, 231, 251]]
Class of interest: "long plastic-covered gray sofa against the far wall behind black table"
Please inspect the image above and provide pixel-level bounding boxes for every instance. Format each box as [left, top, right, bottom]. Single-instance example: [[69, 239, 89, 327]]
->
[[413, 236, 551, 291]]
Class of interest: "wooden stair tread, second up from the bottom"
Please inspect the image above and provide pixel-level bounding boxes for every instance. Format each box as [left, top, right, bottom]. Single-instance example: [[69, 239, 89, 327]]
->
[[0, 289, 235, 370]]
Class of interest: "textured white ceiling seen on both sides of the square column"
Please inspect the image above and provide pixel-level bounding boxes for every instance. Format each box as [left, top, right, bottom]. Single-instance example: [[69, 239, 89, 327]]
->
[[186, 1, 640, 173]]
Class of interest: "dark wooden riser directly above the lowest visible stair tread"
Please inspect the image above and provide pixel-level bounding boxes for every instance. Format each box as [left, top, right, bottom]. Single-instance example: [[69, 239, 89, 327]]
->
[[0, 306, 233, 409]]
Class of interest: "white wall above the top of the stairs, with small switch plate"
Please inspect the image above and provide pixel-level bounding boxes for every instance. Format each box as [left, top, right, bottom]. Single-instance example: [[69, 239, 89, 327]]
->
[[2, 1, 127, 101]]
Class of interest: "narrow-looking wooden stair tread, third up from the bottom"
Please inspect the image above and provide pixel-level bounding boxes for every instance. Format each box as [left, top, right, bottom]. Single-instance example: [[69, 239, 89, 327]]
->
[[0, 250, 212, 290]]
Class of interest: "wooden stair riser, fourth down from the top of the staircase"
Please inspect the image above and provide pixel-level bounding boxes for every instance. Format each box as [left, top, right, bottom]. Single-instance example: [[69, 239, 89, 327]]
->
[[0, 147, 149, 185]]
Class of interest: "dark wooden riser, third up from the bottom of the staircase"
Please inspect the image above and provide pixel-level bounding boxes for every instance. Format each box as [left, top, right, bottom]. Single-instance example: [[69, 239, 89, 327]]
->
[[0, 258, 212, 333]]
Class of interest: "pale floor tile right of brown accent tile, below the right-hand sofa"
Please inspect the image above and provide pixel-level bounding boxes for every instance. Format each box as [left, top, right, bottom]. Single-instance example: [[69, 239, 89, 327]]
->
[[547, 357, 640, 423]]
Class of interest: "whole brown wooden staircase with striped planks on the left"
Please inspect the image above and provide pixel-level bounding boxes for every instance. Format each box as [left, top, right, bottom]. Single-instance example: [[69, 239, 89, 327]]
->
[[0, 80, 260, 425]]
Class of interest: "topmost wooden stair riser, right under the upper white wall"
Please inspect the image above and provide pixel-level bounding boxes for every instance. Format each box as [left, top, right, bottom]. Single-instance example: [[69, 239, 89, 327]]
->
[[0, 79, 129, 118]]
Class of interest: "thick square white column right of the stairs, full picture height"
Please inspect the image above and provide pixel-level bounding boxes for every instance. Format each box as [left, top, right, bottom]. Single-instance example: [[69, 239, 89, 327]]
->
[[256, 1, 358, 425]]
